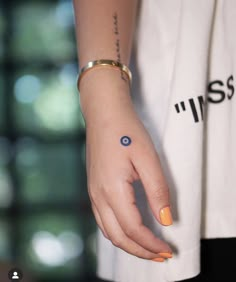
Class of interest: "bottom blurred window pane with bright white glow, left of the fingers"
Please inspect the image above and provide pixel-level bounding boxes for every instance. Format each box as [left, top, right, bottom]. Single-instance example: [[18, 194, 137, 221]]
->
[[19, 212, 84, 281]]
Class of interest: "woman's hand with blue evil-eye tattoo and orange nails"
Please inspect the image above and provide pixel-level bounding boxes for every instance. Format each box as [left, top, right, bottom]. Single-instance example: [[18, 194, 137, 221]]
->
[[79, 69, 172, 261]]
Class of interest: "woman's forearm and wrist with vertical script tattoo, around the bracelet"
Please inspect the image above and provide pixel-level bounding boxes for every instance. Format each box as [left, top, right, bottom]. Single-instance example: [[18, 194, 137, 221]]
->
[[74, 0, 138, 117]]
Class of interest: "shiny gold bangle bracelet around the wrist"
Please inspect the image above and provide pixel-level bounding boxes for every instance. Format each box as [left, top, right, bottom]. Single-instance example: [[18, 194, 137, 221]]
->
[[77, 59, 132, 90]]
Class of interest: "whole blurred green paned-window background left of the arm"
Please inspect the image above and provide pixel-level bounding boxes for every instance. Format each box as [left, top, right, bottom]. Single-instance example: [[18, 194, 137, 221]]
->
[[0, 0, 96, 282]]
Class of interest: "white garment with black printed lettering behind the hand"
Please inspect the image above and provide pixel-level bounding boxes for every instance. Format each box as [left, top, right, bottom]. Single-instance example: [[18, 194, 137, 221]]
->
[[97, 0, 236, 282]]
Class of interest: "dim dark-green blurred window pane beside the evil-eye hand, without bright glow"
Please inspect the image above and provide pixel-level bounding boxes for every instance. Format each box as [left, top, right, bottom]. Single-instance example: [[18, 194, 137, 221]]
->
[[16, 138, 87, 206]]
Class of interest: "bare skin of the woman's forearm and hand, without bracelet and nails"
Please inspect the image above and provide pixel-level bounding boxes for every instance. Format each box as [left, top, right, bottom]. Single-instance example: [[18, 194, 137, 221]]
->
[[74, 0, 172, 259]]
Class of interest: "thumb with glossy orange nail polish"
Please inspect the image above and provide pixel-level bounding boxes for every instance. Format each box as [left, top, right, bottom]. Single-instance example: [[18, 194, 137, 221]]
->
[[133, 144, 173, 226]]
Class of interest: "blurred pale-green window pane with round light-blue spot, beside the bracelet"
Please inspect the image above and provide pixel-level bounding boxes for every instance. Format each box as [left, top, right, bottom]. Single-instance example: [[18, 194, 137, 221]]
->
[[13, 64, 84, 139]]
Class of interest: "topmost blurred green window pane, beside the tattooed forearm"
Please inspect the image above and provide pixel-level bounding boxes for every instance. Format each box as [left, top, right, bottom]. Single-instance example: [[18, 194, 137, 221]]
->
[[11, 1, 76, 63]]
